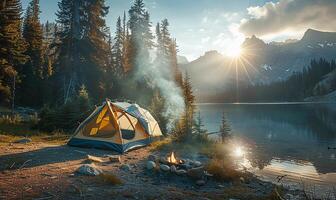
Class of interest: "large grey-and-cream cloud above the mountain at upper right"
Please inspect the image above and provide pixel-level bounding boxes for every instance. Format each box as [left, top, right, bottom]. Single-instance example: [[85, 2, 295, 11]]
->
[[239, 0, 336, 36]]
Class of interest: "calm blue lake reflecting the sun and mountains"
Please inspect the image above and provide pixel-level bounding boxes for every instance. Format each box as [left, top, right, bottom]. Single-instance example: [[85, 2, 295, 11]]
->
[[198, 103, 336, 193]]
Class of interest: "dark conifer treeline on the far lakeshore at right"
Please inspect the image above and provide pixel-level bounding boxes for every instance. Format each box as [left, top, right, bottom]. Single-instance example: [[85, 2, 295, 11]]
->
[[221, 58, 336, 102]]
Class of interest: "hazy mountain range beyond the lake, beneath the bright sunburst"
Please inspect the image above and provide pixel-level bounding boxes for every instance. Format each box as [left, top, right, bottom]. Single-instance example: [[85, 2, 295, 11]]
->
[[181, 29, 336, 101]]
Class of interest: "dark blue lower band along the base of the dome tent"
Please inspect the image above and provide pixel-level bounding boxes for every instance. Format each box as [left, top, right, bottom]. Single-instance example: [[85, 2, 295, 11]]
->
[[68, 138, 151, 153]]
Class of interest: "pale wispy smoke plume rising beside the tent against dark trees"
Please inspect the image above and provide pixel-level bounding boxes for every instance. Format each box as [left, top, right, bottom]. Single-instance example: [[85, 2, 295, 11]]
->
[[136, 47, 184, 130]]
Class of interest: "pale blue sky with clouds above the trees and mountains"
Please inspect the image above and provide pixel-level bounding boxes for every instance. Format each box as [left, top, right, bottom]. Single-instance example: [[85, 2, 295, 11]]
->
[[22, 0, 336, 60]]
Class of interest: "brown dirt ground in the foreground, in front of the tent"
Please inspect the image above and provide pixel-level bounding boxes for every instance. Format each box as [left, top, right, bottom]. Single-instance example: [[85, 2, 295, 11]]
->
[[0, 142, 294, 200]]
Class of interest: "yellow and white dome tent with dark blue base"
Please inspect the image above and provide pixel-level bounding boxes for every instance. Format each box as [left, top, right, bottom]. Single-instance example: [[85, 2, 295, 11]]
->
[[68, 99, 162, 153]]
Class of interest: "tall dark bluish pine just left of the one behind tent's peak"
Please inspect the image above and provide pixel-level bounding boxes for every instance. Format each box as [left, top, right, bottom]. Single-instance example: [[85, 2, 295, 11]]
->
[[54, 0, 84, 103]]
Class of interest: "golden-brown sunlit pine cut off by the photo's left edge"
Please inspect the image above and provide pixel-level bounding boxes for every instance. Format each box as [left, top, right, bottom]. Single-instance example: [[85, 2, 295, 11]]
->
[[0, 0, 27, 103]]
